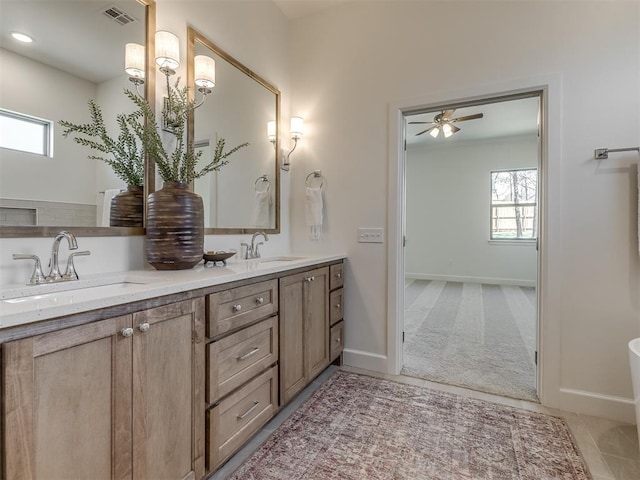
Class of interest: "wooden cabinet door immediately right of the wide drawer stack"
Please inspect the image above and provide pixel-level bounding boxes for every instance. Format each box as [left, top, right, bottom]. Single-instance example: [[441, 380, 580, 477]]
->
[[279, 273, 307, 405]]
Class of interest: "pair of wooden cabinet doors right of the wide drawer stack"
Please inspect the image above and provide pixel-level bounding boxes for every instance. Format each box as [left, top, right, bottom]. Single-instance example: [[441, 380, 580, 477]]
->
[[280, 267, 330, 405]]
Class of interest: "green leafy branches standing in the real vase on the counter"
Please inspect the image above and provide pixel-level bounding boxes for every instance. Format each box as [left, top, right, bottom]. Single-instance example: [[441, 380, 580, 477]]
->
[[126, 79, 249, 184]]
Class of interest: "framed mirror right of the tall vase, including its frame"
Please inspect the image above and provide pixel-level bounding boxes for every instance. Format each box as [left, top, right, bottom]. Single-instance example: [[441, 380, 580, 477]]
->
[[187, 27, 280, 234]]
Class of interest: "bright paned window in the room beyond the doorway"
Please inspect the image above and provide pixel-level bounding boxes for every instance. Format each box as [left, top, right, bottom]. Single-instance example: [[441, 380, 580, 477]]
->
[[491, 168, 538, 240]]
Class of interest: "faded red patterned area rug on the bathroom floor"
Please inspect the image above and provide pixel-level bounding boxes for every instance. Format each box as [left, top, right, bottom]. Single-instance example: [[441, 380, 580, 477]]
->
[[230, 371, 591, 480]]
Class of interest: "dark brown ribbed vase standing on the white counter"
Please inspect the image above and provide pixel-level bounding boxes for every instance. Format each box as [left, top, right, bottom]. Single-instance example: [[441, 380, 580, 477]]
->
[[147, 182, 204, 270]]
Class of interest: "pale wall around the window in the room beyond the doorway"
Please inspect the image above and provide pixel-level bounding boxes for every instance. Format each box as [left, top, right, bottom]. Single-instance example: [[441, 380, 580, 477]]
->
[[405, 135, 538, 286]]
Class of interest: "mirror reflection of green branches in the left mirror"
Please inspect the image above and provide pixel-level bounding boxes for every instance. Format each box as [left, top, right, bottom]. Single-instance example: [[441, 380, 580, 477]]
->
[[58, 100, 144, 186]]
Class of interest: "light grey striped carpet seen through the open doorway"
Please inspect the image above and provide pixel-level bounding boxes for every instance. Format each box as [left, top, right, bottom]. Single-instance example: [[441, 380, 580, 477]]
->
[[402, 280, 538, 401]]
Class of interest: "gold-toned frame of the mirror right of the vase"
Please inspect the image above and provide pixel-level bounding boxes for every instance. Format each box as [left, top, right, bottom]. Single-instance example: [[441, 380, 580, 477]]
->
[[187, 25, 280, 235]]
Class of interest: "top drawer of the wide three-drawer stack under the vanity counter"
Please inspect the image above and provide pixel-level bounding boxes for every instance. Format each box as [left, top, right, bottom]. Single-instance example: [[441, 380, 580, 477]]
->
[[207, 280, 278, 338]]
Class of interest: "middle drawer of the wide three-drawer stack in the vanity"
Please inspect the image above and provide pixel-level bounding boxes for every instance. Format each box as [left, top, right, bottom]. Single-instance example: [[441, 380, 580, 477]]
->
[[207, 316, 278, 403]]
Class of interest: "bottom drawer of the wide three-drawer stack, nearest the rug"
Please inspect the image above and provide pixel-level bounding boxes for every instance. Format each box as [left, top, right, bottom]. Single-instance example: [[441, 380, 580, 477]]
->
[[207, 367, 278, 471]]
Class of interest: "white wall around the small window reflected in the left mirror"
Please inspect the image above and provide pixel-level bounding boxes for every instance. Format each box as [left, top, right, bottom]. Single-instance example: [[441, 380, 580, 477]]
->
[[0, 49, 97, 204]]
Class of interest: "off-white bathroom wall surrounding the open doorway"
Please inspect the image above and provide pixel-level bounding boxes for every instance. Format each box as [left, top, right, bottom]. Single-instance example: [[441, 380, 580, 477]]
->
[[291, 1, 640, 420]]
